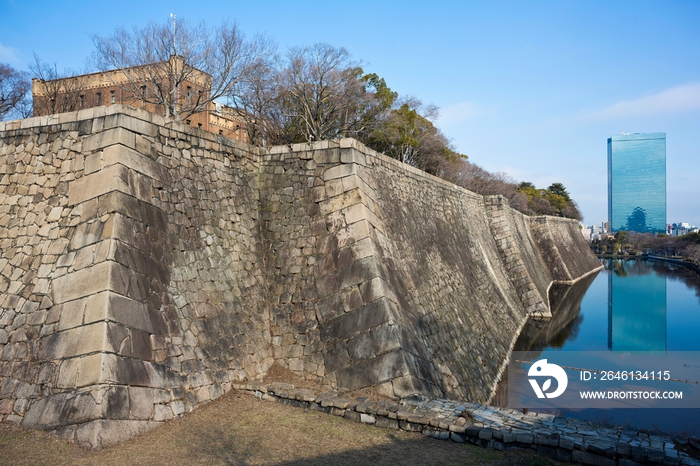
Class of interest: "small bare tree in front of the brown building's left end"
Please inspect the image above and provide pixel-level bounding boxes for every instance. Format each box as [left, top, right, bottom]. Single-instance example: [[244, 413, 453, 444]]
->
[[29, 54, 87, 115]]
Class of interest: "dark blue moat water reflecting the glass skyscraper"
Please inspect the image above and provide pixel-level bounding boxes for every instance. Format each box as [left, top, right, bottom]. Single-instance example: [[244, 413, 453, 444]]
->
[[508, 260, 700, 435]]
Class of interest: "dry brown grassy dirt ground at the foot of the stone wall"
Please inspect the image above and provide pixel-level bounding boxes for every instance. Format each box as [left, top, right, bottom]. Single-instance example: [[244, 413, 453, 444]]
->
[[0, 367, 559, 466]]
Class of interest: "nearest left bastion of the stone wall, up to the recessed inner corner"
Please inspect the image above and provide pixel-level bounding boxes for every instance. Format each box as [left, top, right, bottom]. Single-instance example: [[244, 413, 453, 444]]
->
[[0, 107, 273, 446]]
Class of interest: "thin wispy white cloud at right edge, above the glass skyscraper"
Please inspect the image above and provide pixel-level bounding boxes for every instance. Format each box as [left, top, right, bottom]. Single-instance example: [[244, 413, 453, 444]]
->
[[590, 82, 700, 119]]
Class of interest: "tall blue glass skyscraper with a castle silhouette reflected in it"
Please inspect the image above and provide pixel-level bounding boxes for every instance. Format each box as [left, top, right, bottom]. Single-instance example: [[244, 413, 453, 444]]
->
[[608, 133, 666, 233]]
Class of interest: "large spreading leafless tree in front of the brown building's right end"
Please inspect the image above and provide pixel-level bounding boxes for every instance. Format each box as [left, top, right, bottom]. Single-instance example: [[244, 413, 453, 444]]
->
[[92, 19, 272, 121]]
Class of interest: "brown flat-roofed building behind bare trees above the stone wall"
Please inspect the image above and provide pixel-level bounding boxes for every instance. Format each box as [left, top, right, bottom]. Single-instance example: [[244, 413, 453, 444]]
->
[[32, 57, 250, 142]]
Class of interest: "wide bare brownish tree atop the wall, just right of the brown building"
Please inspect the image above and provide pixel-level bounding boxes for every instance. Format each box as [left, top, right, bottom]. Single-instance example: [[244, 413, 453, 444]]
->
[[229, 44, 397, 144]]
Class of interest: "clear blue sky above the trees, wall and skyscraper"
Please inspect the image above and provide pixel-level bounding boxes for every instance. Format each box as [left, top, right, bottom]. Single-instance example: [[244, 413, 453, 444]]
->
[[0, 0, 700, 226]]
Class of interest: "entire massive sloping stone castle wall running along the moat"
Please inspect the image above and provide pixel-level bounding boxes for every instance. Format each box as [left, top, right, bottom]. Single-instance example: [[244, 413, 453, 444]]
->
[[0, 105, 600, 448]]
